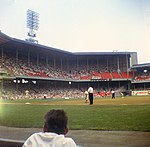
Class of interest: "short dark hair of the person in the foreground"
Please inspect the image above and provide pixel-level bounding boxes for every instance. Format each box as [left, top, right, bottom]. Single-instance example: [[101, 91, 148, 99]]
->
[[44, 109, 68, 134]]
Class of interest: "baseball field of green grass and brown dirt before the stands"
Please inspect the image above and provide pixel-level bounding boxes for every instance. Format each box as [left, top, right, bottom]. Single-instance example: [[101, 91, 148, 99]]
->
[[0, 96, 150, 131]]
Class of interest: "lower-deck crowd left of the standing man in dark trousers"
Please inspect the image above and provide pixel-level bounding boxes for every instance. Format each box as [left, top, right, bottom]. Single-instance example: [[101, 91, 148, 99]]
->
[[1, 84, 84, 100]]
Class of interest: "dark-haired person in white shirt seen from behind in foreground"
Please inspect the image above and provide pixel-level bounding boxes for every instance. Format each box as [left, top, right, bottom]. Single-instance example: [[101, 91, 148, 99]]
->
[[23, 109, 76, 147]]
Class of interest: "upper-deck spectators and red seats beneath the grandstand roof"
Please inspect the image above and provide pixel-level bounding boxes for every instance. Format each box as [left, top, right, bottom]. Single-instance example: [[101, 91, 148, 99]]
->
[[0, 55, 131, 80]]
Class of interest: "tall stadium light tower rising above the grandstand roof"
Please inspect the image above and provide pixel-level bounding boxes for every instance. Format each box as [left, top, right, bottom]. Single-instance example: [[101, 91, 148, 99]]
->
[[26, 9, 39, 43]]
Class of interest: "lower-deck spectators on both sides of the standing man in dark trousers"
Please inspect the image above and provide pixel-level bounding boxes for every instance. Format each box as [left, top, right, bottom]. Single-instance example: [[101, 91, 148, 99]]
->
[[1, 80, 127, 100]]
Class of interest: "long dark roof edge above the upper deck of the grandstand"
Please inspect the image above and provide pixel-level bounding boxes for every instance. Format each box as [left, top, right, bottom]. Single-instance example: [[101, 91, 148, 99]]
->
[[0, 31, 135, 56]]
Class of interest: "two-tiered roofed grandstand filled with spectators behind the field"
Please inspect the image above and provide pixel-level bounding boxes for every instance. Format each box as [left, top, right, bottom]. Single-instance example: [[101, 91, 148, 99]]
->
[[0, 32, 150, 99]]
